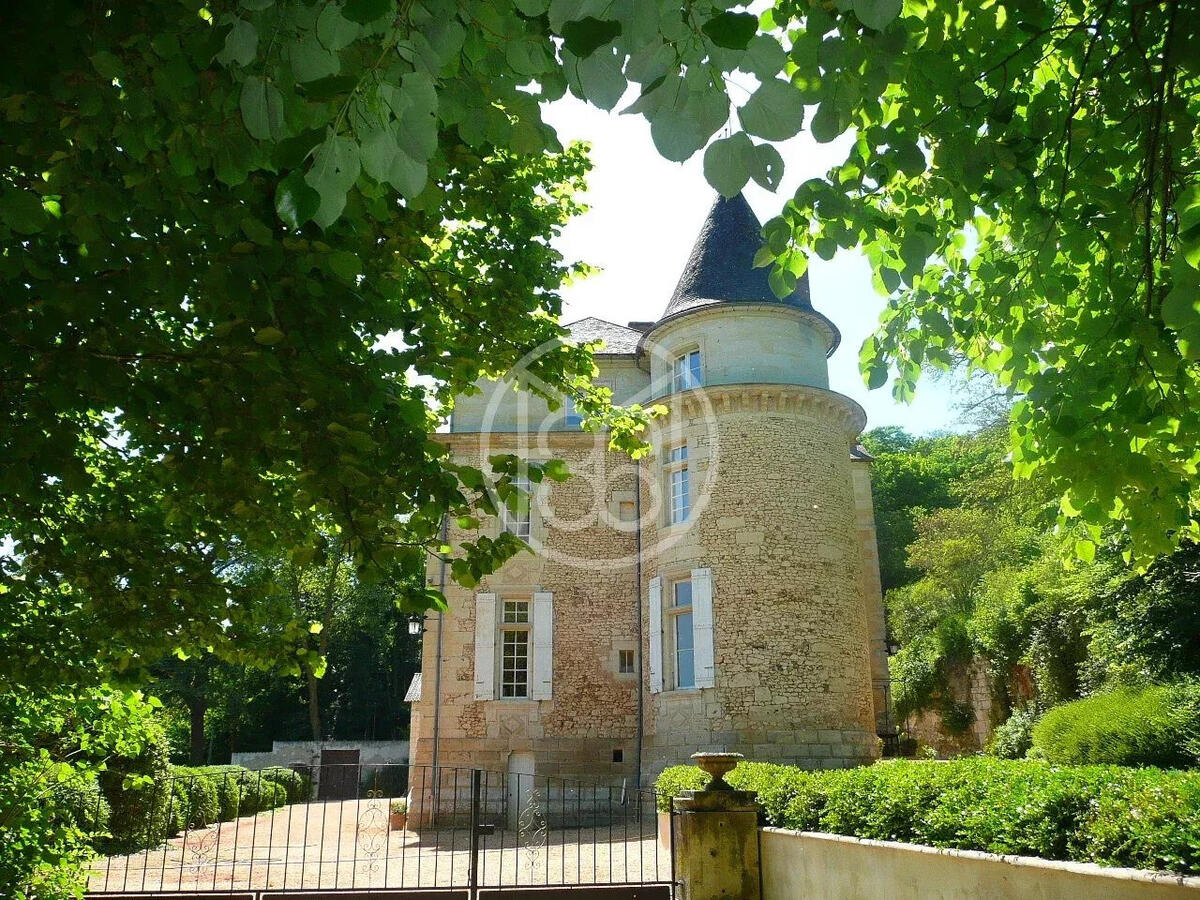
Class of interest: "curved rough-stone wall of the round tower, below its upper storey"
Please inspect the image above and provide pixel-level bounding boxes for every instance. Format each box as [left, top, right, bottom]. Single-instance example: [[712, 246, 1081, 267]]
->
[[643, 385, 878, 770]]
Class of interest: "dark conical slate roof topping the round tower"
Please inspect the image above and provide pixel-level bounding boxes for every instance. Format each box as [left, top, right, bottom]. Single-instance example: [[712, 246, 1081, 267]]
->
[[662, 193, 812, 319]]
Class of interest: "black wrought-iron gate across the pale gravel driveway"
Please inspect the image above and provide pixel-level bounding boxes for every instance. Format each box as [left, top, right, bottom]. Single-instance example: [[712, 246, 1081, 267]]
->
[[89, 763, 673, 900]]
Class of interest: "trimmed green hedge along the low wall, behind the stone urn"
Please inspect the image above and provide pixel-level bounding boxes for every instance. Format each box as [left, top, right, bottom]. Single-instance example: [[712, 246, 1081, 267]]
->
[[655, 756, 1200, 875]]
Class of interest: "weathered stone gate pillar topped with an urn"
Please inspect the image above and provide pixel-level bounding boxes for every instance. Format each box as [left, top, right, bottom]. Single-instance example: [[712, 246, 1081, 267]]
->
[[672, 754, 762, 900]]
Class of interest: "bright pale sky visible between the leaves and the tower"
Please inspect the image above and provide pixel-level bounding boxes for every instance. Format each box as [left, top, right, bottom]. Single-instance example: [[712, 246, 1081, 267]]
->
[[544, 96, 965, 434]]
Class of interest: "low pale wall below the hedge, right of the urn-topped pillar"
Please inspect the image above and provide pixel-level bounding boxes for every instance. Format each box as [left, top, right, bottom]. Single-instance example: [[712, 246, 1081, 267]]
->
[[761, 828, 1200, 900]]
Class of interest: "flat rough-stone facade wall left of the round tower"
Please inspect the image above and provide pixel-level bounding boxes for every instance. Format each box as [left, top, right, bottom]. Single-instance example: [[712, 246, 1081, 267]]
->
[[412, 432, 637, 782]]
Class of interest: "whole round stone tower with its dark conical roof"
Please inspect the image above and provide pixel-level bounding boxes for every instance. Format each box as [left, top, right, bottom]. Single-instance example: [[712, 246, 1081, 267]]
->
[[641, 196, 886, 772]]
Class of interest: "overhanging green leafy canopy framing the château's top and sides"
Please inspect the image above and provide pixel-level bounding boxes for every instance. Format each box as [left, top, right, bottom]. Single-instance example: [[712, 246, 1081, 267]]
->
[[0, 0, 1200, 696]]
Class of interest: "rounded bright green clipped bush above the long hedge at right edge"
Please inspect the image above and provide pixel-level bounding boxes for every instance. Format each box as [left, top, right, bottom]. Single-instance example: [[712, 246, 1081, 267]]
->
[[1033, 680, 1200, 768]]
